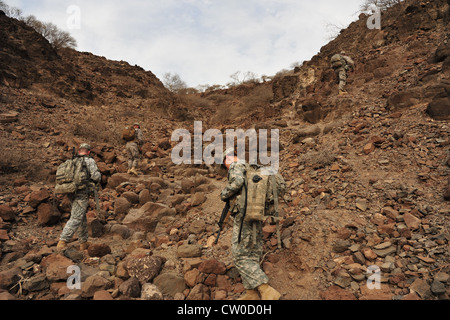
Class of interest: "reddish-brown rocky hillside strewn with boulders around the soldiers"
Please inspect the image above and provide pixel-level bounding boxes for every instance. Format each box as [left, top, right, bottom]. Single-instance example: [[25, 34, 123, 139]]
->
[[0, 0, 450, 300]]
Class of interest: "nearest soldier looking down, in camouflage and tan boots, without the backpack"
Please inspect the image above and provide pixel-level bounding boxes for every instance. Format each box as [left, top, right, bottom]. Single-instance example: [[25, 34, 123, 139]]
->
[[220, 149, 281, 300]]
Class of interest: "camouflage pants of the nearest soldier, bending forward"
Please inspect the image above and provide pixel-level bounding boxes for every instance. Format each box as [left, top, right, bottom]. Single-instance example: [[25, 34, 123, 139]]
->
[[231, 214, 269, 290]]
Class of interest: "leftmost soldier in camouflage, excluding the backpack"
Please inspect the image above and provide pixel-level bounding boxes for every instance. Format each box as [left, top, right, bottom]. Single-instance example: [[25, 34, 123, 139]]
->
[[57, 143, 101, 250]]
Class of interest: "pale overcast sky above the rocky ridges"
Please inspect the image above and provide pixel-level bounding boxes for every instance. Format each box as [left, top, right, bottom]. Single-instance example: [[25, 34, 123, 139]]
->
[[5, 0, 363, 87]]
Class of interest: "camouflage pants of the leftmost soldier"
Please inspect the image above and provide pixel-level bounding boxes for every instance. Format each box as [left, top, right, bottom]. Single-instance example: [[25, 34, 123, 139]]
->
[[60, 194, 89, 243]]
